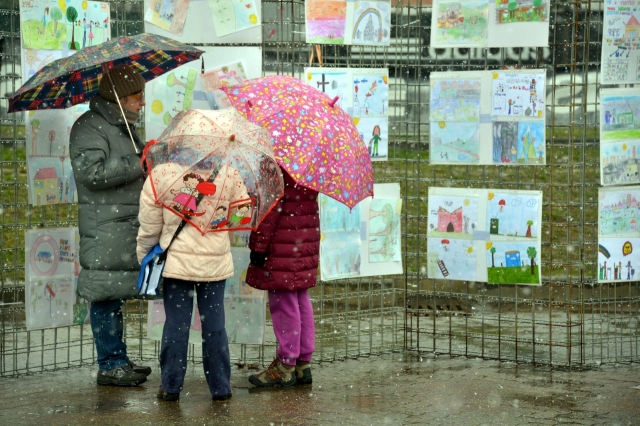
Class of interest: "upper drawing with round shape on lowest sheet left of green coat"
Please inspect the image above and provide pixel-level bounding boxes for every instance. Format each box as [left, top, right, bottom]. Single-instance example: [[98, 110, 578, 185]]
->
[[25, 227, 79, 279]]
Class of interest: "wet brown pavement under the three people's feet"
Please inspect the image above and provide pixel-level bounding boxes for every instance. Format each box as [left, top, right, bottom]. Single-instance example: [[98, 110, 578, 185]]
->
[[0, 354, 640, 426]]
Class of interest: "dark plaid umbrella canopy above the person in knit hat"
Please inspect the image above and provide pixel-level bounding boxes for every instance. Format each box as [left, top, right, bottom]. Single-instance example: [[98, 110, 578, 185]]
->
[[9, 33, 203, 112]]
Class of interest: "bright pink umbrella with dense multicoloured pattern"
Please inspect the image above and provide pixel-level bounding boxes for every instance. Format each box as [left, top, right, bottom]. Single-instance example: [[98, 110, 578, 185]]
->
[[222, 75, 373, 208]]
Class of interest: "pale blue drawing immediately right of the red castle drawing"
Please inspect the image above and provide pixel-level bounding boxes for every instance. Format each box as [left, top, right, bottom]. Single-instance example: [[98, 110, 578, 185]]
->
[[486, 192, 540, 240]]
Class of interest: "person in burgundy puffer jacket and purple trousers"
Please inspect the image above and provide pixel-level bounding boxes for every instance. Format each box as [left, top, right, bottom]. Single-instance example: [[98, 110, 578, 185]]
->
[[246, 169, 320, 387]]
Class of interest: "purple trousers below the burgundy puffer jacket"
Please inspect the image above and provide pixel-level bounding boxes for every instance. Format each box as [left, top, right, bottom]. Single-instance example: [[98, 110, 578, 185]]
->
[[269, 290, 316, 365]]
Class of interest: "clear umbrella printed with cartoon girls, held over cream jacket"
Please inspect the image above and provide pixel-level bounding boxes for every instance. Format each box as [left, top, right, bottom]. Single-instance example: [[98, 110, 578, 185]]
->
[[143, 108, 284, 234]]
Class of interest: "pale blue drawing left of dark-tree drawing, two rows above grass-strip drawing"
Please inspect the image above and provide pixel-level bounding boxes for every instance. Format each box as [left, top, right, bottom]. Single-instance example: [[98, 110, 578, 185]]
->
[[429, 121, 480, 164]]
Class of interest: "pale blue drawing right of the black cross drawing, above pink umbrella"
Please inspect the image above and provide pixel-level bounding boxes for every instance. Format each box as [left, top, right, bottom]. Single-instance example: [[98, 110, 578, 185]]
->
[[352, 70, 389, 117]]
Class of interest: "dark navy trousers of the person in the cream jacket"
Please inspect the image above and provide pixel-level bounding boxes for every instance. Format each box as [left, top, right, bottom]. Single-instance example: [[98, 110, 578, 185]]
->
[[160, 278, 231, 396]]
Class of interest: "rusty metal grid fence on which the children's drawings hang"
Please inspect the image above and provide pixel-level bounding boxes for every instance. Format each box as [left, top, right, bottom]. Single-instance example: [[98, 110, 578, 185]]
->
[[0, 0, 640, 376]]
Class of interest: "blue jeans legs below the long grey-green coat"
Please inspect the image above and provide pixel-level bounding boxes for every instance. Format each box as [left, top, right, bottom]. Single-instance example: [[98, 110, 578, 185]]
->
[[90, 300, 129, 371]]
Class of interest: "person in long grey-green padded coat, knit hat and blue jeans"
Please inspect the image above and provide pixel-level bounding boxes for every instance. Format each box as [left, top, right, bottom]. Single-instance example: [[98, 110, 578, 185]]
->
[[69, 65, 151, 386]]
